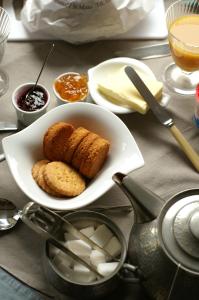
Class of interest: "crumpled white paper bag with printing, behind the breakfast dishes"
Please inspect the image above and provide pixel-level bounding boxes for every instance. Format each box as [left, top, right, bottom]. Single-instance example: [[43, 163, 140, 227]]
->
[[21, 0, 155, 44]]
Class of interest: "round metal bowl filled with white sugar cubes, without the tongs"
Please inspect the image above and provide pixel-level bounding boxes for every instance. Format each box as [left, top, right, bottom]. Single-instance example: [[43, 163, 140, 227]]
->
[[44, 210, 135, 299]]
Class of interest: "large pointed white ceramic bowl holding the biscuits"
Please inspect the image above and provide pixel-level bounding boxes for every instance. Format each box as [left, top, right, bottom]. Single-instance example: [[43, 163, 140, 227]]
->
[[2, 102, 144, 210]]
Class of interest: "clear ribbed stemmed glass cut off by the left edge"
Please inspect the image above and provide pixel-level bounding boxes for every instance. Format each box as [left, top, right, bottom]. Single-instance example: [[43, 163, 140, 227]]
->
[[0, 7, 10, 96]]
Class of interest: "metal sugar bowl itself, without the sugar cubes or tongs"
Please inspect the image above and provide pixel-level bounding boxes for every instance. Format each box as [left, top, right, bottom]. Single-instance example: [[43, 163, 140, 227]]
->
[[44, 211, 137, 299]]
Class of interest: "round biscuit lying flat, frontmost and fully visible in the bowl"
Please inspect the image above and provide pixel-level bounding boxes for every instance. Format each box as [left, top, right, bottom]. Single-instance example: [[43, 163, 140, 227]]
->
[[44, 161, 85, 197]]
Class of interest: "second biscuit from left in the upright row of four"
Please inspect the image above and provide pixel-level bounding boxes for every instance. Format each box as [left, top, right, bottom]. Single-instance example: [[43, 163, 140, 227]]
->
[[64, 127, 89, 163]]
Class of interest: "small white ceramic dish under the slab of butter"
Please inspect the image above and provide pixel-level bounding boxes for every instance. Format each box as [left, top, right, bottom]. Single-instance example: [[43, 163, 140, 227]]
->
[[88, 57, 169, 114]]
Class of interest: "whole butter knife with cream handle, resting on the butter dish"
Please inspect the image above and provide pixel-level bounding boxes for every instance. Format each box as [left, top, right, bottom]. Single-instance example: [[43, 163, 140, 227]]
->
[[125, 66, 199, 172]]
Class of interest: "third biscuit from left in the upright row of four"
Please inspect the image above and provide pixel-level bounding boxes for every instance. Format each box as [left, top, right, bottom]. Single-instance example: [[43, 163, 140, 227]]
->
[[72, 132, 99, 170]]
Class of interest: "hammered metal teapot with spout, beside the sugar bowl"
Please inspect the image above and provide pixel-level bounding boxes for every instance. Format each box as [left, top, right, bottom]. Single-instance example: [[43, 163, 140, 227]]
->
[[113, 173, 199, 300]]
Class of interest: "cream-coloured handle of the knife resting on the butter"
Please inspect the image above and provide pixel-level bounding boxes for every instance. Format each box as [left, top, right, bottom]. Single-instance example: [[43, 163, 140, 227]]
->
[[169, 125, 199, 172]]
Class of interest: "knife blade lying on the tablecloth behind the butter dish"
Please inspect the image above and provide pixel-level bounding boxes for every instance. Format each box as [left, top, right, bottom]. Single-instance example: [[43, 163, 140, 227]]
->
[[115, 43, 171, 59]]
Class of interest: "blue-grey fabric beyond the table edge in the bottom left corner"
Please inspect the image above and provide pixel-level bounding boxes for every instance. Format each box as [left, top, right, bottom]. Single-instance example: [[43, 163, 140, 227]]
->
[[0, 268, 53, 300]]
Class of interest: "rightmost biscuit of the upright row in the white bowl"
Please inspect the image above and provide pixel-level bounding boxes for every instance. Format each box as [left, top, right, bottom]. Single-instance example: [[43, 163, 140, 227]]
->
[[79, 138, 110, 178]]
